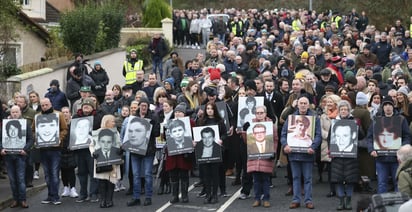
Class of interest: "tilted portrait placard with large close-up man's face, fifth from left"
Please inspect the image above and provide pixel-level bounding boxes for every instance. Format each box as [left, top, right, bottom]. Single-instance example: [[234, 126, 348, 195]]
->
[[123, 116, 152, 155]]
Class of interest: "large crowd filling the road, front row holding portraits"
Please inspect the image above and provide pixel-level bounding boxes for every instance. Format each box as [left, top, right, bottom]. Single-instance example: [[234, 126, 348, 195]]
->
[[0, 8, 412, 210]]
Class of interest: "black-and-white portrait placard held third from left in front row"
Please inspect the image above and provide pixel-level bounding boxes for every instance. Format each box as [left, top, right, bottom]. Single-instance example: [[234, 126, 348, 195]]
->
[[69, 116, 93, 150]]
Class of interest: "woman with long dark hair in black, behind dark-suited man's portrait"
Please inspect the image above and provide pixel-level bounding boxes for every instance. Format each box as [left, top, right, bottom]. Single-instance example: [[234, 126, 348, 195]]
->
[[196, 102, 227, 204]]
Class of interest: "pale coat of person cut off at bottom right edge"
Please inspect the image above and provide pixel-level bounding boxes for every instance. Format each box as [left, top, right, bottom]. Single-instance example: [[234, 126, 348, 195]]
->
[[396, 158, 412, 197]]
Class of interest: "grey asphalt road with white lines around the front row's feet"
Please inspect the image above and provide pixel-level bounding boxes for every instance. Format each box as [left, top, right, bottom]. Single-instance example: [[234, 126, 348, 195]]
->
[[0, 165, 374, 212]]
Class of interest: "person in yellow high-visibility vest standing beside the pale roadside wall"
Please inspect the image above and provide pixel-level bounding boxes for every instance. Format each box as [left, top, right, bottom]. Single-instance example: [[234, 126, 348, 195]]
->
[[123, 49, 144, 93]]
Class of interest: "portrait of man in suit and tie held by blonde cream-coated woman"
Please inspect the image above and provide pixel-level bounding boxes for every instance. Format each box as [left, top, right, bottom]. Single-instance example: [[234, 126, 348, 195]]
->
[[94, 129, 123, 167]]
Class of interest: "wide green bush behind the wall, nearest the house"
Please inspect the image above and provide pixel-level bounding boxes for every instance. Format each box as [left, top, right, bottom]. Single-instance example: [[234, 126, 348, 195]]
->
[[60, 3, 124, 54]]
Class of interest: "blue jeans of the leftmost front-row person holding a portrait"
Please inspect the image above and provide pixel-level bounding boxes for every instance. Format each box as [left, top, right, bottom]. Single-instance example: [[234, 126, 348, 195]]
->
[[4, 155, 27, 202]]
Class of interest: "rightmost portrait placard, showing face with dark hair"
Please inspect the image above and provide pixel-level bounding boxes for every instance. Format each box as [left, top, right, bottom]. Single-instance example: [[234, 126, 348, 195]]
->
[[373, 117, 402, 155]]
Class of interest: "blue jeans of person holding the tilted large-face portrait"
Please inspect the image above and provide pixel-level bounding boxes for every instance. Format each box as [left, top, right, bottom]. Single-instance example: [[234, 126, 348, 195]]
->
[[130, 154, 154, 199]]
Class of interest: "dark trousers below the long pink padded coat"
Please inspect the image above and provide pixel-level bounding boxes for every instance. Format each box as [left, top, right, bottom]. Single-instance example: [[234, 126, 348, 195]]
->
[[252, 172, 271, 201]]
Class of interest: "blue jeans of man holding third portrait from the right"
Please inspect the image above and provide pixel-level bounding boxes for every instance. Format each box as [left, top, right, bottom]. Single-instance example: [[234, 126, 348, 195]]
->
[[290, 161, 313, 204]]
